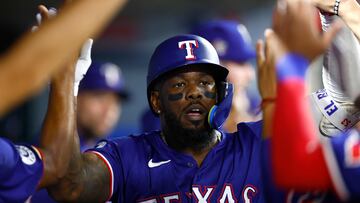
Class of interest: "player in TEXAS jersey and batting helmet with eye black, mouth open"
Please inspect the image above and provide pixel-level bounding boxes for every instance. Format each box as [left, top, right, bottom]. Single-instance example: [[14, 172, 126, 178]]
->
[[50, 35, 264, 203]]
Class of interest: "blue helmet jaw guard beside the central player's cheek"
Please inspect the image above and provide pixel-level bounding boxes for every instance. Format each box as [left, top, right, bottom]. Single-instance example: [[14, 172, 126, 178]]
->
[[208, 82, 234, 129]]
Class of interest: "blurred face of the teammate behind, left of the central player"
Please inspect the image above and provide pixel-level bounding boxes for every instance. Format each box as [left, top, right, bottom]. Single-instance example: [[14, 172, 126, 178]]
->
[[77, 91, 121, 138]]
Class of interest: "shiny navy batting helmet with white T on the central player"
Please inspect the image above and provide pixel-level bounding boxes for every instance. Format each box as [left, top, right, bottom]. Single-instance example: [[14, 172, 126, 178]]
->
[[147, 35, 229, 114]]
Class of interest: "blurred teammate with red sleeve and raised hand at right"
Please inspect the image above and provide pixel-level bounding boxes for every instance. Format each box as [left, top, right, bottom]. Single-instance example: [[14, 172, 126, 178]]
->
[[264, 2, 360, 201]]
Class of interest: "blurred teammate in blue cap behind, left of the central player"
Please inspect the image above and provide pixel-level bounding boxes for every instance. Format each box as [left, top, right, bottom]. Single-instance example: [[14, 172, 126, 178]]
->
[[77, 62, 128, 151]]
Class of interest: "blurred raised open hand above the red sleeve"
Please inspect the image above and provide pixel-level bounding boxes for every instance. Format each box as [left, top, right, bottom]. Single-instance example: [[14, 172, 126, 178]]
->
[[273, 0, 341, 61]]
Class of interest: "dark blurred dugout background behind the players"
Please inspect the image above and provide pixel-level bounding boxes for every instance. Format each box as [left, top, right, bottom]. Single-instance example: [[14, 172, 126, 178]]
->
[[0, 0, 322, 142]]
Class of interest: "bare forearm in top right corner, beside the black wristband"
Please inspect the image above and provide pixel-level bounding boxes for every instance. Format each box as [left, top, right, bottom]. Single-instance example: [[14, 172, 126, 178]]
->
[[339, 0, 360, 40]]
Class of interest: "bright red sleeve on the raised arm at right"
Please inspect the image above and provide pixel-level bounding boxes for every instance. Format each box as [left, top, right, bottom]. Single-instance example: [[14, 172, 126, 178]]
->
[[271, 63, 331, 191]]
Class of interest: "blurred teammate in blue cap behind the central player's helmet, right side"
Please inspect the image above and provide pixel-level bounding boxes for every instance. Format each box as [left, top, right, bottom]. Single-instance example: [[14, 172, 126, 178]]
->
[[192, 20, 256, 132]]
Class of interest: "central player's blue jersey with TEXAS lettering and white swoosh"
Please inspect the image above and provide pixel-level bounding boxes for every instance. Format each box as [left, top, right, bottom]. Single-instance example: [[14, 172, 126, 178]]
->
[[88, 122, 265, 203]]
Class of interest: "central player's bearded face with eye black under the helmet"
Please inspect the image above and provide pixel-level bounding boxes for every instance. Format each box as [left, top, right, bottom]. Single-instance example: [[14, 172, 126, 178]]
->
[[160, 68, 216, 130]]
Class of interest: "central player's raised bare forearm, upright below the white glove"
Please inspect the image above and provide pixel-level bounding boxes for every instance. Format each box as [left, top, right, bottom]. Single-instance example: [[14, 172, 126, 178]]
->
[[40, 63, 76, 187]]
